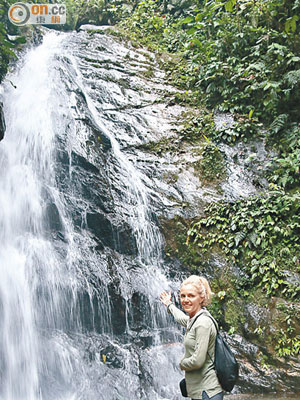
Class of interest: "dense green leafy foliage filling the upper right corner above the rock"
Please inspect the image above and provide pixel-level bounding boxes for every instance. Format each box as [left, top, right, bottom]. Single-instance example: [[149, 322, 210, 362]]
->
[[118, 0, 300, 148]]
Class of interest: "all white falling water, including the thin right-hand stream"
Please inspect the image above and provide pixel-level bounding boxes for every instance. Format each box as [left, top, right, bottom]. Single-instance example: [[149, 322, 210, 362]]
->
[[0, 29, 183, 400]]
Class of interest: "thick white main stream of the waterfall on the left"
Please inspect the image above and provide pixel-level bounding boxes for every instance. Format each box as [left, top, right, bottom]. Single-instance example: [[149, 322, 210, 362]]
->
[[0, 35, 90, 400]]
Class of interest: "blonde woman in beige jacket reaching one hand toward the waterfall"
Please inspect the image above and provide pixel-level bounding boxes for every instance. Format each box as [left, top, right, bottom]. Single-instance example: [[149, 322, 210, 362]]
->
[[160, 275, 223, 400]]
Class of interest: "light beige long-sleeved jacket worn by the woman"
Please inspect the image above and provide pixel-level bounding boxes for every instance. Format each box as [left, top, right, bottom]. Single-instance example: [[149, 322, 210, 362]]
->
[[168, 304, 222, 399]]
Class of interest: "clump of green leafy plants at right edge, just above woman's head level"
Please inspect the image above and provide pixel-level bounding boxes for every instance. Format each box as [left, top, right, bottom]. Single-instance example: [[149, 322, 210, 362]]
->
[[188, 191, 300, 298]]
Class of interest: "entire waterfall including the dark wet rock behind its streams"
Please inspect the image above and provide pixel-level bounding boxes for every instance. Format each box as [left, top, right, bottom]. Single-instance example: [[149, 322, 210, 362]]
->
[[0, 32, 181, 400]]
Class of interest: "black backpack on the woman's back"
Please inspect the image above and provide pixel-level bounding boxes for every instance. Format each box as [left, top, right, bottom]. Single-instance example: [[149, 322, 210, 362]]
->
[[205, 314, 239, 392]]
